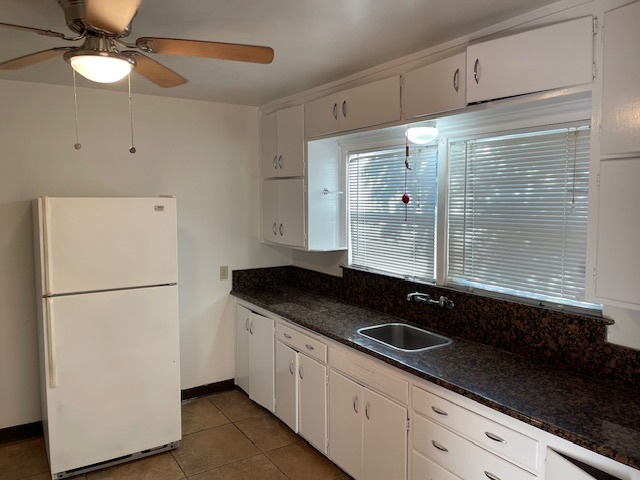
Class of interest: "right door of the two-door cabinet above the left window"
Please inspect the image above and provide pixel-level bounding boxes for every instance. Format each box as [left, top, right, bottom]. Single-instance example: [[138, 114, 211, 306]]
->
[[338, 75, 400, 130]]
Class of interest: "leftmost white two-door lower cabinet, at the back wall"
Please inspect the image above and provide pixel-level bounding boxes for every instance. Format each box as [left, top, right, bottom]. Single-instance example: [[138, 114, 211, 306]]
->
[[235, 305, 275, 412]]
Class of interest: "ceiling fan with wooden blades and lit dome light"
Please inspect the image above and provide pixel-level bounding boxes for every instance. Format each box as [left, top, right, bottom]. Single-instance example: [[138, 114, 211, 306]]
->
[[0, 0, 273, 87]]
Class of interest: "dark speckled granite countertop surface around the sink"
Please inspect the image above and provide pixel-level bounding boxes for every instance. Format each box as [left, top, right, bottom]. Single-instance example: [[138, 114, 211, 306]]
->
[[231, 286, 640, 469]]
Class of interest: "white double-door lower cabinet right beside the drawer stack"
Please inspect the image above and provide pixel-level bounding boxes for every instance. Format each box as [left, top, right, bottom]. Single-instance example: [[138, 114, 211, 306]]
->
[[329, 370, 407, 480]]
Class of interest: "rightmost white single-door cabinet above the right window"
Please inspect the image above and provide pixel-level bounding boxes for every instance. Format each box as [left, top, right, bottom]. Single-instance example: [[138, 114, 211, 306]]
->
[[467, 16, 593, 103]]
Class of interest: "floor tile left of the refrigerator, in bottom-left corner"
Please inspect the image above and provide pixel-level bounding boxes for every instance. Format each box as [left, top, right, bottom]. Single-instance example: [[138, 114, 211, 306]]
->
[[0, 436, 51, 480]]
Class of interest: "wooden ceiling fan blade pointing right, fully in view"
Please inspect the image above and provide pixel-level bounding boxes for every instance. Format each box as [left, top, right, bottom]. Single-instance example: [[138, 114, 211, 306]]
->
[[136, 37, 273, 63]]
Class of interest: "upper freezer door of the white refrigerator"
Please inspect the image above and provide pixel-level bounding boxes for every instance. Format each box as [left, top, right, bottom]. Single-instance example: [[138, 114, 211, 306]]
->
[[37, 197, 178, 295]]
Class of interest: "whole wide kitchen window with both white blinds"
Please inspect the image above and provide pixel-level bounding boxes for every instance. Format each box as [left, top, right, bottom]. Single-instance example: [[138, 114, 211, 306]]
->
[[347, 122, 599, 309]]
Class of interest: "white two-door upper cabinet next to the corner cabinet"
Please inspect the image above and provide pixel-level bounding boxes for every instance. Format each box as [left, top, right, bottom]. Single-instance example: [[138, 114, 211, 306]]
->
[[304, 75, 400, 138]]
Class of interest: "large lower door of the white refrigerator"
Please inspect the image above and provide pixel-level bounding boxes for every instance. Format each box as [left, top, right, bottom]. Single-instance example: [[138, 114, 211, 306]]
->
[[41, 286, 181, 474]]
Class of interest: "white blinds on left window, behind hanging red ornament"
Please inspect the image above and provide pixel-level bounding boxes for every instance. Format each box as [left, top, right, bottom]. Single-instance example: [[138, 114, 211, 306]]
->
[[349, 146, 438, 282]]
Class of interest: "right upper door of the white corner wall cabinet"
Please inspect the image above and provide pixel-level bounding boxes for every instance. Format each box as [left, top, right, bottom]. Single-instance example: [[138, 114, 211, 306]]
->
[[276, 105, 304, 177]]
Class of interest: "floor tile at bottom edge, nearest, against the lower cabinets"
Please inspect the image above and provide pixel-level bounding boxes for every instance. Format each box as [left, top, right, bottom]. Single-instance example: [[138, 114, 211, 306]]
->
[[266, 441, 344, 480]]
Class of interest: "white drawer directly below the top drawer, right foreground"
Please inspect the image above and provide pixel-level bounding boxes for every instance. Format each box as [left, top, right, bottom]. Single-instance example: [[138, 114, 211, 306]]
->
[[413, 415, 537, 480]]
